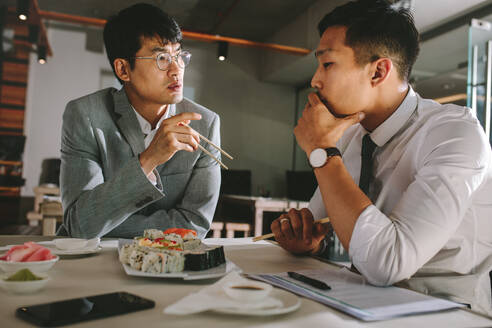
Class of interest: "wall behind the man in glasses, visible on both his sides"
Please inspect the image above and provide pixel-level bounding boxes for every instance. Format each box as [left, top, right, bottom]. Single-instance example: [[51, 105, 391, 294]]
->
[[22, 28, 295, 196]]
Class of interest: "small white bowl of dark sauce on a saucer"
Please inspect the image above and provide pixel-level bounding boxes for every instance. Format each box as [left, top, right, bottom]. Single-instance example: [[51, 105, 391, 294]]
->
[[223, 280, 273, 302]]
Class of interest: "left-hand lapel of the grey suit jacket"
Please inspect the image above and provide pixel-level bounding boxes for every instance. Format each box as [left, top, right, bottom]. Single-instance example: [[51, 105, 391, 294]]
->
[[113, 88, 145, 156]]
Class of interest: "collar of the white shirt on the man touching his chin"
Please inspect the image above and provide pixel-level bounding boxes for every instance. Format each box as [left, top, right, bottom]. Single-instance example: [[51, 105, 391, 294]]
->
[[371, 86, 417, 147]]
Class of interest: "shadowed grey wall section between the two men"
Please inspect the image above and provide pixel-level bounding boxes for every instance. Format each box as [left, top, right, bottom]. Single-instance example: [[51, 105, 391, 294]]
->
[[185, 42, 295, 196]]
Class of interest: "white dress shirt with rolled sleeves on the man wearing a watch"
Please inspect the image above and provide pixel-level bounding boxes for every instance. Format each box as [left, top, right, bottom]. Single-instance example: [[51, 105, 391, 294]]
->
[[309, 88, 492, 315]]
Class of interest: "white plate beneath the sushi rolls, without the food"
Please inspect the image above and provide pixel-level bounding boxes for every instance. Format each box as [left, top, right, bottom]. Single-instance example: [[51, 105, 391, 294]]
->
[[118, 239, 241, 280]]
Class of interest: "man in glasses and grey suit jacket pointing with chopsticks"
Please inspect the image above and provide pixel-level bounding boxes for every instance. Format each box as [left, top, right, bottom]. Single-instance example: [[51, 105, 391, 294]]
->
[[58, 4, 220, 238]]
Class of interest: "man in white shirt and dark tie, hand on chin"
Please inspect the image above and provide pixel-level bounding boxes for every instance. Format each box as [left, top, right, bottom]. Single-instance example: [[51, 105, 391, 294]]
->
[[271, 0, 492, 315]]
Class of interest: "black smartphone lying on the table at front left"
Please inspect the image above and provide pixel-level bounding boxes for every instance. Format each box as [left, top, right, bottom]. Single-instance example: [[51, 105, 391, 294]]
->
[[16, 292, 155, 327]]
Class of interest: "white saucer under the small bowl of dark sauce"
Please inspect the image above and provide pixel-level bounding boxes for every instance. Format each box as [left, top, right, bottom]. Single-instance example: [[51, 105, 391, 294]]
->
[[212, 288, 301, 316]]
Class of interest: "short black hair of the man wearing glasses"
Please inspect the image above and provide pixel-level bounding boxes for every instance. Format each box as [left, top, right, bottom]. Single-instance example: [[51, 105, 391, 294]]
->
[[104, 3, 183, 84]]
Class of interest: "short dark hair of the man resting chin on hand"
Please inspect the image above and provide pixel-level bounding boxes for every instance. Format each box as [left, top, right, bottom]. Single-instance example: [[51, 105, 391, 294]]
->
[[318, 0, 420, 81]]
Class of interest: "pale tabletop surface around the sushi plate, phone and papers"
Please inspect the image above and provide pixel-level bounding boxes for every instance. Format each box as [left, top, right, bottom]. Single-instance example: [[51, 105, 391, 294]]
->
[[0, 236, 492, 328]]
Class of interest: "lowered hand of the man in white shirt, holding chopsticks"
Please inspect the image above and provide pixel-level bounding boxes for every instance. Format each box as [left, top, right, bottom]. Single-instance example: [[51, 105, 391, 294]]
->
[[271, 208, 329, 255]]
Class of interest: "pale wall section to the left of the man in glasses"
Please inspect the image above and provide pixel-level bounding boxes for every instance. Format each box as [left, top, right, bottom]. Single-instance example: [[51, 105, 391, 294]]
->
[[21, 29, 111, 196]]
